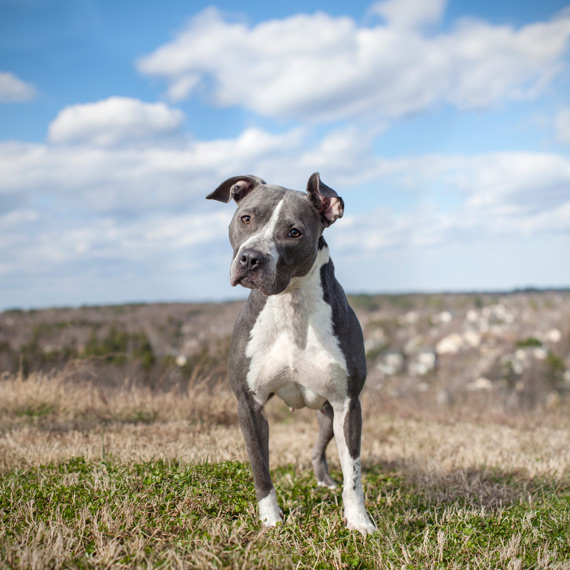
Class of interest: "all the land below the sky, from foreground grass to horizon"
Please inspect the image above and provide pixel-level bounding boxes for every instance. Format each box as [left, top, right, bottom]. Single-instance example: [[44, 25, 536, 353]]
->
[[0, 293, 570, 569]]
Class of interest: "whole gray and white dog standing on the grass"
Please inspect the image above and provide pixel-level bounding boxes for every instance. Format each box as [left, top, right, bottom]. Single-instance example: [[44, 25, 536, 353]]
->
[[207, 173, 376, 534]]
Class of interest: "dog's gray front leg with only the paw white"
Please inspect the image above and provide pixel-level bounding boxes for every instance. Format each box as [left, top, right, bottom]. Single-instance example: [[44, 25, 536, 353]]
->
[[234, 393, 282, 526]]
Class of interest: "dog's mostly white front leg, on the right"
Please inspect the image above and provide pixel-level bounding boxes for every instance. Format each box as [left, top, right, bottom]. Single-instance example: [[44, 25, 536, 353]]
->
[[333, 398, 376, 534]]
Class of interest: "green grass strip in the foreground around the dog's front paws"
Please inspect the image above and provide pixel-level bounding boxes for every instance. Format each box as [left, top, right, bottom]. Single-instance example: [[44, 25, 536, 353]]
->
[[0, 458, 570, 569]]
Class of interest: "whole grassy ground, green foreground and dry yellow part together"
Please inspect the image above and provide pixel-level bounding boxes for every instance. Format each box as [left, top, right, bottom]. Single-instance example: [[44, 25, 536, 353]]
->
[[0, 375, 570, 569]]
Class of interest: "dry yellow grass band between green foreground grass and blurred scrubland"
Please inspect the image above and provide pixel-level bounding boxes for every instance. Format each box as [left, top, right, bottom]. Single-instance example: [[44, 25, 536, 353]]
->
[[0, 368, 570, 488]]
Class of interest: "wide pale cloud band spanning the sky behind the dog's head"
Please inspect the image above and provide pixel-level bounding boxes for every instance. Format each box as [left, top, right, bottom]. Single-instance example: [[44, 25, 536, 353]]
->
[[0, 123, 570, 276]]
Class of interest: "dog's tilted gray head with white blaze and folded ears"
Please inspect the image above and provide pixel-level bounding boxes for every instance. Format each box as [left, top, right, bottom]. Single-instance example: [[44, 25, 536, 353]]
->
[[207, 172, 344, 295]]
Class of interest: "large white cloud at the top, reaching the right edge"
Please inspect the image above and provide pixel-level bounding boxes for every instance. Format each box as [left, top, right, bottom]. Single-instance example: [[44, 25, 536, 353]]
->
[[138, 0, 570, 121]]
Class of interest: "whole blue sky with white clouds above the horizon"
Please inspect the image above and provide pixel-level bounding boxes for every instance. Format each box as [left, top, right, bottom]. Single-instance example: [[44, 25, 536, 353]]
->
[[0, 0, 570, 310]]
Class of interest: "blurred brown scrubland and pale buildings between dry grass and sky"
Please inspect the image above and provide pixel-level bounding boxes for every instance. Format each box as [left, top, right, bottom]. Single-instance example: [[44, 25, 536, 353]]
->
[[0, 290, 570, 410]]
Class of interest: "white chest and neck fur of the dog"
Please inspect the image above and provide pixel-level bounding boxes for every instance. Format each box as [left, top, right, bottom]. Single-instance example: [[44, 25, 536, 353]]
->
[[246, 249, 347, 409]]
